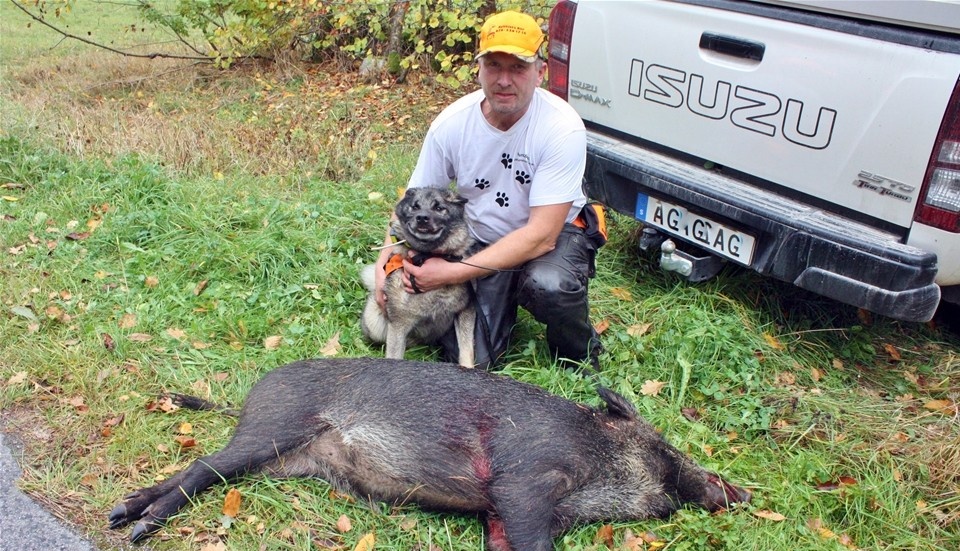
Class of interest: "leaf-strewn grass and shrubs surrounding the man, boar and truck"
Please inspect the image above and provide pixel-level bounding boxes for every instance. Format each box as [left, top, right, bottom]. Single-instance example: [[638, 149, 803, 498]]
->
[[0, 0, 960, 551]]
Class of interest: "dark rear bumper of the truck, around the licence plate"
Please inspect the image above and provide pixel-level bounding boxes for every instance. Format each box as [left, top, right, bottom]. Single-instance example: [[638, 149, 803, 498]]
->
[[586, 131, 940, 322]]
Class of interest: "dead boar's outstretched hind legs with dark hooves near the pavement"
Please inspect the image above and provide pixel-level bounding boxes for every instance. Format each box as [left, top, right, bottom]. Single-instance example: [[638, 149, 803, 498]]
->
[[109, 432, 299, 542]]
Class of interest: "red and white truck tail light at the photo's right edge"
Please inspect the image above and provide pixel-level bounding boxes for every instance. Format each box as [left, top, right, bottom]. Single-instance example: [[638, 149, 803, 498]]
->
[[915, 81, 960, 233]]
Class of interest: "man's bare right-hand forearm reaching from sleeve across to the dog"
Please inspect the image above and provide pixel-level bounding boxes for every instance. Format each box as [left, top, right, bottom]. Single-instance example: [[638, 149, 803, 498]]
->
[[403, 202, 573, 292]]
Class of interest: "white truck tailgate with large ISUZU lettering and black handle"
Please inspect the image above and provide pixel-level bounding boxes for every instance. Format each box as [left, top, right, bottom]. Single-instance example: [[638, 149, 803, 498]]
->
[[569, 1, 960, 228]]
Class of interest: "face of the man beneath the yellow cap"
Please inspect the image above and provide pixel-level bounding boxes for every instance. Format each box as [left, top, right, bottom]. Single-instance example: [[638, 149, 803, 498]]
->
[[479, 52, 546, 124]]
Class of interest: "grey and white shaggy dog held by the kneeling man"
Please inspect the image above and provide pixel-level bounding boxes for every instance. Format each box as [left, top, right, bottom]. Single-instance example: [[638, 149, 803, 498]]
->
[[360, 188, 480, 367]]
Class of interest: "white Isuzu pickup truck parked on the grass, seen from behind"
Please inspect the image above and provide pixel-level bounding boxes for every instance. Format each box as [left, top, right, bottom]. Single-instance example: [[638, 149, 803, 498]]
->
[[548, 0, 960, 321]]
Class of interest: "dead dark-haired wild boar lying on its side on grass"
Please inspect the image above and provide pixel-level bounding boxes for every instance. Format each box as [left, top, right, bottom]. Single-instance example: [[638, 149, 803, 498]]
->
[[110, 358, 750, 551]]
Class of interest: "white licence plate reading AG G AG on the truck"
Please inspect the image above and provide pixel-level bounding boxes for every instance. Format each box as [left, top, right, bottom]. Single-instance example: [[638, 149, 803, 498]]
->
[[635, 193, 756, 266]]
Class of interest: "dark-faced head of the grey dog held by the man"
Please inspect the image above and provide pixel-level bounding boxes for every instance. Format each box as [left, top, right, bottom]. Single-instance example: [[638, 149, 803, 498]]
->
[[395, 188, 467, 253]]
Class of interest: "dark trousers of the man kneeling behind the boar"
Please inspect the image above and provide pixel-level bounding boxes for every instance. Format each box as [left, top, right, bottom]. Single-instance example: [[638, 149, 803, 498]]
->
[[440, 224, 600, 369]]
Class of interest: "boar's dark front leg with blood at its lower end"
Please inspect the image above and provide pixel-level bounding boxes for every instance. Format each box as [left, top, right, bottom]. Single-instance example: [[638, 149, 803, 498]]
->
[[486, 471, 571, 551]]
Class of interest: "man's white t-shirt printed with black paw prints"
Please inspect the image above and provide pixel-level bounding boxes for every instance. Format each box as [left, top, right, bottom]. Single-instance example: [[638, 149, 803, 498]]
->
[[409, 88, 587, 243]]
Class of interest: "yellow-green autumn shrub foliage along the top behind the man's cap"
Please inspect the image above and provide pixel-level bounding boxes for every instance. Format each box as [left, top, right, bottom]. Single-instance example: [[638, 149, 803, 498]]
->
[[16, 0, 553, 85]]
